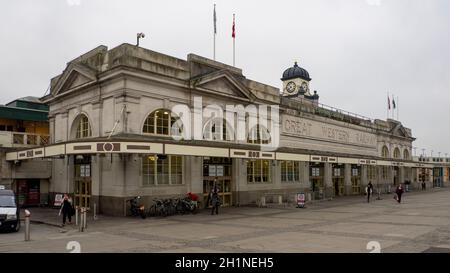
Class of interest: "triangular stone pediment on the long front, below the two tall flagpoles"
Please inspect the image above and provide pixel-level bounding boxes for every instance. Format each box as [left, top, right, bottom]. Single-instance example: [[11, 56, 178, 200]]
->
[[191, 70, 254, 100]]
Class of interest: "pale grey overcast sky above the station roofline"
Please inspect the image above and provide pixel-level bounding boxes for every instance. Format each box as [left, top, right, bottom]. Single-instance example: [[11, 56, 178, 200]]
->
[[0, 0, 450, 156]]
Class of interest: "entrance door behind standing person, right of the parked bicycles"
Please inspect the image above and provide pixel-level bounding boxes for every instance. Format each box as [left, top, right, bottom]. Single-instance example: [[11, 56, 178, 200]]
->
[[203, 157, 233, 207]]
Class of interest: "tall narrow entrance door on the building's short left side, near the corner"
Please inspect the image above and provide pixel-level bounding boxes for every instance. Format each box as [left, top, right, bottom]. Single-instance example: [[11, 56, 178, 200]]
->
[[74, 156, 91, 208]]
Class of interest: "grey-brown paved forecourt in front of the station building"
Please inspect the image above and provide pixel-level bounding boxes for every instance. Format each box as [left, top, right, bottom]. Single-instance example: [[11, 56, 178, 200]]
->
[[0, 188, 450, 253]]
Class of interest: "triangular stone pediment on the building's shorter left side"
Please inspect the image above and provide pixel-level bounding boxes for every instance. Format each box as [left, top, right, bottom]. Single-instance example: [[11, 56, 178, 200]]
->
[[52, 64, 96, 95]]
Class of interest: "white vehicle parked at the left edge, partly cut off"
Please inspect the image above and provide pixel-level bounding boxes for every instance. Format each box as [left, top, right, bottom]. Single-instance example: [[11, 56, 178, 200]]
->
[[0, 189, 20, 232]]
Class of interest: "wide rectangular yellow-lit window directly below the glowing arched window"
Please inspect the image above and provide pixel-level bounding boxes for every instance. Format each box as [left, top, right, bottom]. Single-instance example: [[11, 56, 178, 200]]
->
[[142, 155, 183, 186]]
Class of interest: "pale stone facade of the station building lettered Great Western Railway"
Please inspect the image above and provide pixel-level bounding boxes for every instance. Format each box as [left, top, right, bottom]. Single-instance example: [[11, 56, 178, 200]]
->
[[12, 44, 416, 215]]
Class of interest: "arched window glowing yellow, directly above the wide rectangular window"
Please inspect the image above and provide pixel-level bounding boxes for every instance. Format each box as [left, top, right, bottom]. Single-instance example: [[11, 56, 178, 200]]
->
[[142, 109, 182, 136]]
